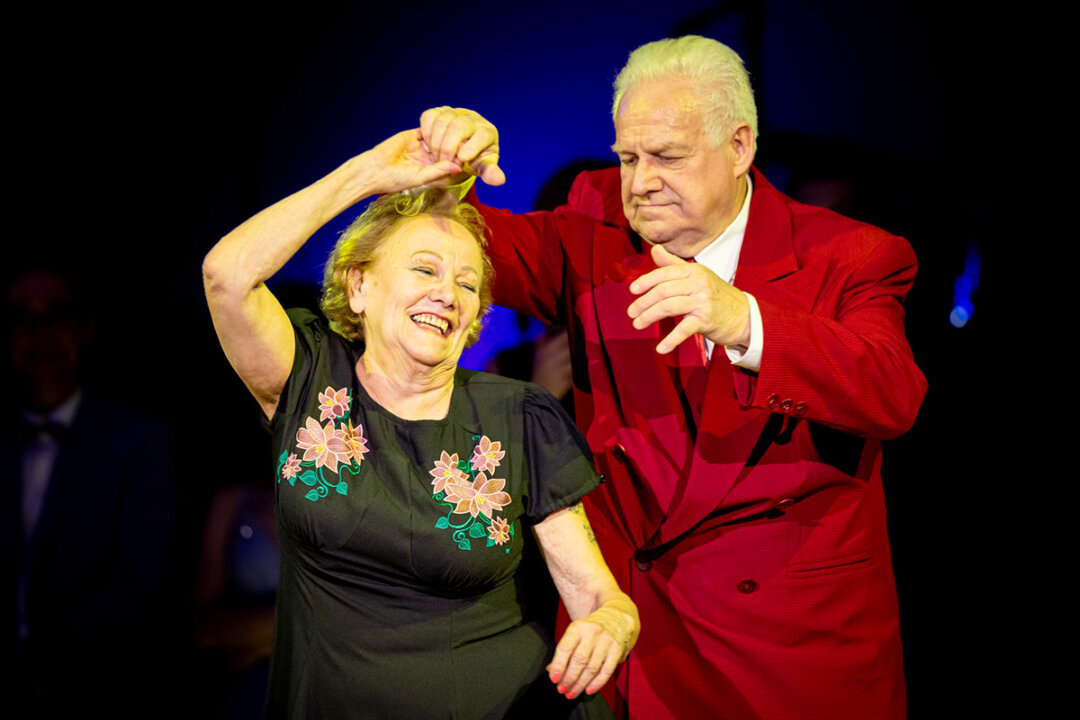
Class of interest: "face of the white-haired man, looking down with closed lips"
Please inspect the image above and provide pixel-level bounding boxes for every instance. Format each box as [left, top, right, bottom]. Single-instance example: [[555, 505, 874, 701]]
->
[[612, 77, 753, 258]]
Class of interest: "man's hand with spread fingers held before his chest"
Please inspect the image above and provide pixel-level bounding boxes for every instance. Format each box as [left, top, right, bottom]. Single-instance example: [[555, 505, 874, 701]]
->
[[626, 245, 750, 355]]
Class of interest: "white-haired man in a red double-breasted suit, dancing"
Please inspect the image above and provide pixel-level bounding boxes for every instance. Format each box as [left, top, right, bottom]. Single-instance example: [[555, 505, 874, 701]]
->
[[421, 37, 926, 720]]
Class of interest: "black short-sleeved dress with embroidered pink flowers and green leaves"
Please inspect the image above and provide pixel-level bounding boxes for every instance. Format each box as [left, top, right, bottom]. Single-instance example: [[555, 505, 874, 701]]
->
[[268, 311, 607, 720]]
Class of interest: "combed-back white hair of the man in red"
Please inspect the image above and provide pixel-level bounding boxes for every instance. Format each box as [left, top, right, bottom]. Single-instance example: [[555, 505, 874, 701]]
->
[[611, 35, 757, 150]]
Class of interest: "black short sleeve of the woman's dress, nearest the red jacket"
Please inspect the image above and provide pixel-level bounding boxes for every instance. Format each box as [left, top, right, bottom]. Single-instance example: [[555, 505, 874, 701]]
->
[[523, 384, 600, 522]]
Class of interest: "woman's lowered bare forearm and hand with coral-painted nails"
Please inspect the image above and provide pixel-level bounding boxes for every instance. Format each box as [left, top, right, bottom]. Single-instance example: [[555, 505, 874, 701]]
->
[[534, 503, 642, 699]]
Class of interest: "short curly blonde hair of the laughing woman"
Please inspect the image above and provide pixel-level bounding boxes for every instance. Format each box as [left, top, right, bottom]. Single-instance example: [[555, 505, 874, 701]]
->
[[319, 187, 495, 345]]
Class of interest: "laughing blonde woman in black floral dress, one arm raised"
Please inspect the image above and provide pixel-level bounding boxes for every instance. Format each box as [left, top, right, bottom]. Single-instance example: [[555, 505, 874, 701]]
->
[[203, 131, 638, 719]]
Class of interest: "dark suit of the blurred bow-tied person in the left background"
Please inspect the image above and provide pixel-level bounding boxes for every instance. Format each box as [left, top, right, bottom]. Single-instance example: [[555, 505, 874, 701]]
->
[[0, 394, 177, 717]]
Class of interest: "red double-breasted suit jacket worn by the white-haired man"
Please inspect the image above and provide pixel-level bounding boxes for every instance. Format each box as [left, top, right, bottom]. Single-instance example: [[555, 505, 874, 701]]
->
[[481, 169, 926, 720]]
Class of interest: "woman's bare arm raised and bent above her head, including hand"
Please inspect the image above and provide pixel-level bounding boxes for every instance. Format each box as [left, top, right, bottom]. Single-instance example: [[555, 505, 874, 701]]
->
[[203, 130, 461, 418]]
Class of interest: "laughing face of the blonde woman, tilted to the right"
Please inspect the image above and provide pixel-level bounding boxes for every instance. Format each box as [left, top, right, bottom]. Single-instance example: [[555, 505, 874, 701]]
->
[[349, 215, 484, 369]]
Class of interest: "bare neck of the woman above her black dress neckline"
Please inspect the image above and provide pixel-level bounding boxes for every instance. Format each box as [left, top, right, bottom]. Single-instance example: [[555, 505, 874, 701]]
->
[[356, 351, 457, 420]]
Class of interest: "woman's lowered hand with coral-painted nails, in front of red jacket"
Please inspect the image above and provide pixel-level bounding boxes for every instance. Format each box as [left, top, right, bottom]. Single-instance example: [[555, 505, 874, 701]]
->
[[546, 596, 640, 699]]
